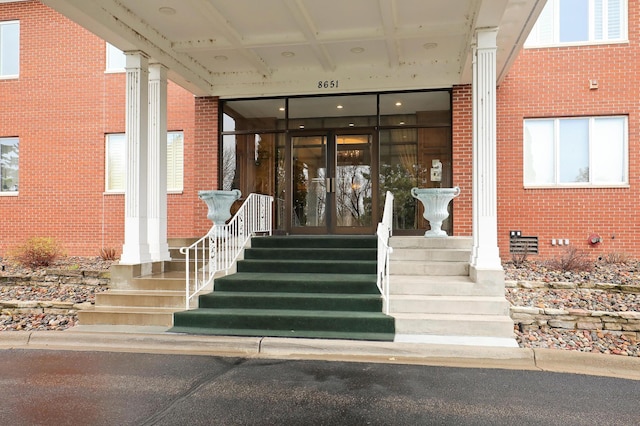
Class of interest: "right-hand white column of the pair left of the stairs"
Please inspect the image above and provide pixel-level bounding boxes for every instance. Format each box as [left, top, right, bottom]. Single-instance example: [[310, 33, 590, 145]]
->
[[147, 64, 171, 262]]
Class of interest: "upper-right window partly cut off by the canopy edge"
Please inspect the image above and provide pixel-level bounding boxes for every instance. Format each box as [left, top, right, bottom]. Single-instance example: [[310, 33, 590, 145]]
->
[[525, 0, 627, 47]]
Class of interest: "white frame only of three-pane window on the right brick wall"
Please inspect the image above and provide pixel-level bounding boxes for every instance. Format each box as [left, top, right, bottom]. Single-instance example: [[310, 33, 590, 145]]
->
[[522, 115, 629, 189]]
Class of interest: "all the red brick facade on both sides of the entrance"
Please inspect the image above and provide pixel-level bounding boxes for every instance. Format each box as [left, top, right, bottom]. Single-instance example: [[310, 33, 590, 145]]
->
[[0, 1, 640, 259]]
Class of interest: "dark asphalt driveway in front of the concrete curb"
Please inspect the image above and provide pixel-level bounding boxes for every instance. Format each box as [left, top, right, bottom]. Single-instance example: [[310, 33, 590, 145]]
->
[[0, 349, 640, 426]]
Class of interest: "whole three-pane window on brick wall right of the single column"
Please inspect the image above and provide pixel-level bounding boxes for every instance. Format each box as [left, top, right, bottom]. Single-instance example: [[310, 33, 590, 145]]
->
[[524, 116, 628, 187]]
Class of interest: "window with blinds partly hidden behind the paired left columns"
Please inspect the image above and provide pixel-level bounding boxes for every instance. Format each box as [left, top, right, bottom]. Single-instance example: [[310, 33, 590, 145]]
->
[[105, 132, 184, 192]]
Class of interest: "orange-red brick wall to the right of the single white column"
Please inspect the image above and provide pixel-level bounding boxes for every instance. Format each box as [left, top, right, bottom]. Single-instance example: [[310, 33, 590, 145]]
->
[[497, 2, 640, 259]]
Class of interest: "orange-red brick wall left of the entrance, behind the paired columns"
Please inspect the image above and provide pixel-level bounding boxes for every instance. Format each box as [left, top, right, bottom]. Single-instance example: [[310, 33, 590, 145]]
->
[[0, 1, 202, 256]]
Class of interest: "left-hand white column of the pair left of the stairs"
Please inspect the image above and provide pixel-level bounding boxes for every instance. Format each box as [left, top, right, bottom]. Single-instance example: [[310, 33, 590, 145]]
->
[[120, 51, 151, 265]]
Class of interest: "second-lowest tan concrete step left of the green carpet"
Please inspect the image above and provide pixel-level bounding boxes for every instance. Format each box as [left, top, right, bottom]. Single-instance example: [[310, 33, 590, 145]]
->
[[96, 289, 186, 309]]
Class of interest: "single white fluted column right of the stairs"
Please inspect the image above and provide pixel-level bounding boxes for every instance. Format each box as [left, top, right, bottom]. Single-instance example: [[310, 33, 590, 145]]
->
[[471, 28, 504, 282]]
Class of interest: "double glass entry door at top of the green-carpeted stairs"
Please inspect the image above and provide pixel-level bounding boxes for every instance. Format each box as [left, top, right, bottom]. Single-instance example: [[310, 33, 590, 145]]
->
[[289, 131, 377, 234]]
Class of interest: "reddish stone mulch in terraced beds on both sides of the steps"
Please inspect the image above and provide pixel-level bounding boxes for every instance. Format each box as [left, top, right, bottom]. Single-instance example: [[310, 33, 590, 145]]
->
[[0, 257, 640, 357]]
